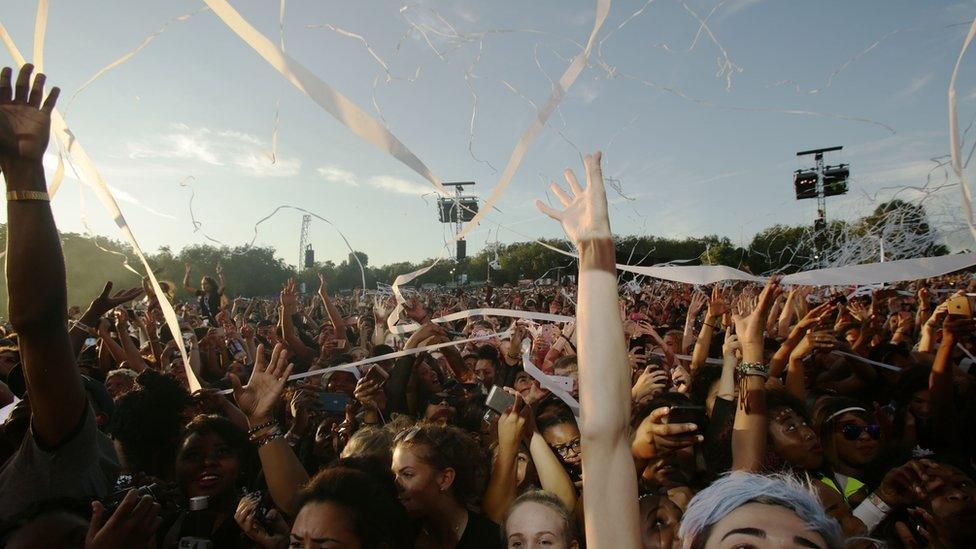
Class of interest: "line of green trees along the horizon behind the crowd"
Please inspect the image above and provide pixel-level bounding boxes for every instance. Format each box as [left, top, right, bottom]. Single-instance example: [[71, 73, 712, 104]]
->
[[0, 200, 949, 311]]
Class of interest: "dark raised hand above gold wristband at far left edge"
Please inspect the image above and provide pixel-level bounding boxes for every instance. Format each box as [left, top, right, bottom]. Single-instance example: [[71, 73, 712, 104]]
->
[[0, 63, 60, 164]]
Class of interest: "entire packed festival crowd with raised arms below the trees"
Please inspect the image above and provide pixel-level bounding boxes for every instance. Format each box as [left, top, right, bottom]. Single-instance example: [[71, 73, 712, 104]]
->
[[0, 65, 976, 549]]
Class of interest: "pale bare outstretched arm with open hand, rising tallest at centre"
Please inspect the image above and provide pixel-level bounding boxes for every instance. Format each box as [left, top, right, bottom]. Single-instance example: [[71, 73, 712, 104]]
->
[[536, 152, 641, 549]]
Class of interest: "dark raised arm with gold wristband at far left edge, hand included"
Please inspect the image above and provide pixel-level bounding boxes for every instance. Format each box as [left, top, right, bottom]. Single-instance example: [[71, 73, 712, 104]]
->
[[0, 64, 78, 447]]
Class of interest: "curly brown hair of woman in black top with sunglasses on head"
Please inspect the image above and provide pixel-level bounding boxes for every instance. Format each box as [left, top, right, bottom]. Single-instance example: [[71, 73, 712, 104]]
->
[[393, 424, 487, 504]]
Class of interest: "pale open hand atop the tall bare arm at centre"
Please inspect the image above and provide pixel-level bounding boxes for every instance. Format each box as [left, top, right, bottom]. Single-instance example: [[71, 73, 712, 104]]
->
[[535, 151, 611, 246]]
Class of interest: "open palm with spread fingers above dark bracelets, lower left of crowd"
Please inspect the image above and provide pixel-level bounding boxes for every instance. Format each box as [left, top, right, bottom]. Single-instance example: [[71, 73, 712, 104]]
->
[[229, 344, 294, 426]]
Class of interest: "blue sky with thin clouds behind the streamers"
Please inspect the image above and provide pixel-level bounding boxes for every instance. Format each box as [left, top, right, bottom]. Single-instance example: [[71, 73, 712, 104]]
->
[[0, 0, 976, 264]]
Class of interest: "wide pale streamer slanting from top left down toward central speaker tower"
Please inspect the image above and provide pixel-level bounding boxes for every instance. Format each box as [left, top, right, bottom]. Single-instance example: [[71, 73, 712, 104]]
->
[[203, 0, 449, 196]]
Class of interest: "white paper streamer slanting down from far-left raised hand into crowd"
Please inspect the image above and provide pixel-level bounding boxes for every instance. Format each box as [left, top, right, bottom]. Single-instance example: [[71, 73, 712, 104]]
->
[[0, 24, 201, 392]]
